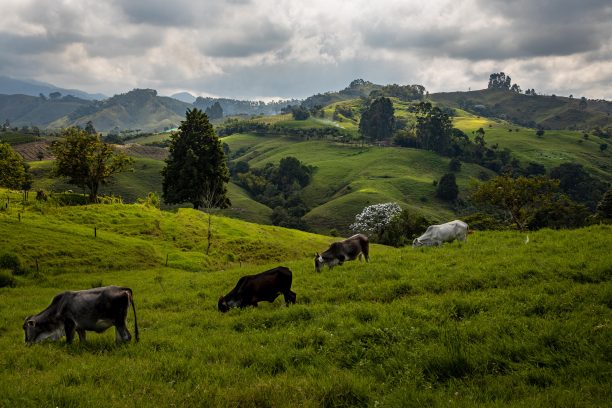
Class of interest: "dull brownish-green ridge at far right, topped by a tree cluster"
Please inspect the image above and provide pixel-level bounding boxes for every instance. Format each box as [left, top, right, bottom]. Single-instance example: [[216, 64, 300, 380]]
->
[[429, 89, 612, 129]]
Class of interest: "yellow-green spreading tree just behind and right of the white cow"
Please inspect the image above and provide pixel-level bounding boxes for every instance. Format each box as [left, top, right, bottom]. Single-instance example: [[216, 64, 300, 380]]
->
[[471, 176, 559, 231]]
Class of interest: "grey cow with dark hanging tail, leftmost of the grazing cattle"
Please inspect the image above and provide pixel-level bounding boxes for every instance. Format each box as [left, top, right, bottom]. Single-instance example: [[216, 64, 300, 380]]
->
[[23, 286, 138, 345]]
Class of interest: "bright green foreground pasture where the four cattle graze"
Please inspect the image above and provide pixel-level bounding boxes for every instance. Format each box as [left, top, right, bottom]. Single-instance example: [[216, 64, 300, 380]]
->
[[0, 192, 612, 407]]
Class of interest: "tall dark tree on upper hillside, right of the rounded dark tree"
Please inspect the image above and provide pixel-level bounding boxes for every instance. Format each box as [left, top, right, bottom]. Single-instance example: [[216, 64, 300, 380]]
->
[[416, 102, 453, 154]]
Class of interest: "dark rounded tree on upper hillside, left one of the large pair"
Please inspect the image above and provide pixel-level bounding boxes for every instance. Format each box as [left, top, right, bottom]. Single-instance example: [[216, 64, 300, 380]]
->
[[359, 97, 395, 142]]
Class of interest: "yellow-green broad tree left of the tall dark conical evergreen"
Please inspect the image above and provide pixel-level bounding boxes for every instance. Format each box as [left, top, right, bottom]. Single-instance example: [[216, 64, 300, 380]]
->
[[51, 127, 134, 202]]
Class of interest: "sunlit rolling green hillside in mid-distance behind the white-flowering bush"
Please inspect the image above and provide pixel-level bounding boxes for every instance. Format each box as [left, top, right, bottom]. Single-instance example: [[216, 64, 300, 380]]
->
[[223, 135, 494, 233]]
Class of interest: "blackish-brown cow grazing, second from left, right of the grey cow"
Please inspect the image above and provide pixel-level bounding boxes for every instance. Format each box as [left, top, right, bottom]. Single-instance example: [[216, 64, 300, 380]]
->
[[217, 266, 296, 313]]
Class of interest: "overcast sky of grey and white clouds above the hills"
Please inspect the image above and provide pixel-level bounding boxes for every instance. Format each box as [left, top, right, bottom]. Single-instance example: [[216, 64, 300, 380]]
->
[[0, 0, 612, 100]]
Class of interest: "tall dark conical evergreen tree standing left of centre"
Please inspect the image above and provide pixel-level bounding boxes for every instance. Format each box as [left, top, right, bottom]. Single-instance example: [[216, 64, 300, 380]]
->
[[162, 108, 230, 209]]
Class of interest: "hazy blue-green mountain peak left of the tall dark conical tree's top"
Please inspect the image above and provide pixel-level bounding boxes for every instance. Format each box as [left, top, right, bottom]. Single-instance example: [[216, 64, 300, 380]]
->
[[50, 89, 193, 132]]
